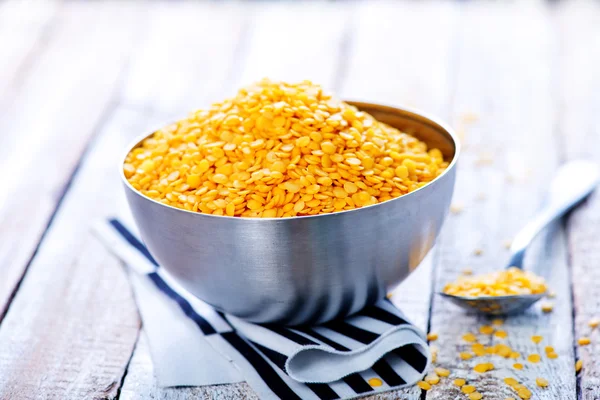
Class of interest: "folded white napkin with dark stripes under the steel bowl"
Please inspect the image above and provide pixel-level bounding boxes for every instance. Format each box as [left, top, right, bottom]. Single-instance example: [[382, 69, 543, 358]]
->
[[94, 219, 430, 399]]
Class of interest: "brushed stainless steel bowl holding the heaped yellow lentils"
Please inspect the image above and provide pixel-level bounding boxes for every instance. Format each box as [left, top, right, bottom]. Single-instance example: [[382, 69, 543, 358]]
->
[[121, 102, 459, 325]]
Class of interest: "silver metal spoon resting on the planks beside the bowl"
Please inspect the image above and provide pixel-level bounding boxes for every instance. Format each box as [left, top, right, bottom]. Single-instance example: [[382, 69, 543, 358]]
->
[[439, 160, 600, 315]]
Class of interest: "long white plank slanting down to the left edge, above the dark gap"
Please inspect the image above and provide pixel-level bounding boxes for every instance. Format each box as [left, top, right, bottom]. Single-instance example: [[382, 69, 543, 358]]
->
[[0, 3, 144, 319]]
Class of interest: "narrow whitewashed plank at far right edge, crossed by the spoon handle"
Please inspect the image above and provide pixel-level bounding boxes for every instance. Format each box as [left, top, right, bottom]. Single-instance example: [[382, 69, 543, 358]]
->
[[558, 1, 600, 400]]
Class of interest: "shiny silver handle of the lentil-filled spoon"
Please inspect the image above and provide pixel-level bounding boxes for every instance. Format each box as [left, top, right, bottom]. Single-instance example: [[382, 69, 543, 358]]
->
[[508, 160, 600, 268]]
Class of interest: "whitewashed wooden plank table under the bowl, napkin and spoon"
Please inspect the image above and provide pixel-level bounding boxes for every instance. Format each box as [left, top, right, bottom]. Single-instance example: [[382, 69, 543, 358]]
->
[[0, 0, 600, 400]]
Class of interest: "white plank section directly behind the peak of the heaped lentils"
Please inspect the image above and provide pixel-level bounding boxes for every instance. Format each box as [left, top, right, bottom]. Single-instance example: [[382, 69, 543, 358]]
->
[[234, 2, 353, 90]]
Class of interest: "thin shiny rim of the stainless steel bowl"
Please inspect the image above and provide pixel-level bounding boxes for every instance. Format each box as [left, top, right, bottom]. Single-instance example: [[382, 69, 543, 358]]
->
[[118, 100, 461, 223]]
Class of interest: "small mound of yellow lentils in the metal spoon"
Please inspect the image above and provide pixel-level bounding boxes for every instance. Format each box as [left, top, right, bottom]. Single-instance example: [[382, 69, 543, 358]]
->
[[443, 267, 547, 297]]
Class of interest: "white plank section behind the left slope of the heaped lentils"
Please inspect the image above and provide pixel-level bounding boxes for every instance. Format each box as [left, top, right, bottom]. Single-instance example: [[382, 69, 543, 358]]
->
[[120, 2, 251, 118]]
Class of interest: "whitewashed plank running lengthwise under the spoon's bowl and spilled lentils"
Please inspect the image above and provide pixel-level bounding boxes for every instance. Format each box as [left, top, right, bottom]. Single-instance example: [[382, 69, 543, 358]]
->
[[426, 3, 575, 400]]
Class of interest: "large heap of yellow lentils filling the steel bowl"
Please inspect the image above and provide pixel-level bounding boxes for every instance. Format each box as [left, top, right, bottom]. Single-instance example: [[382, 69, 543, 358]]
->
[[123, 80, 448, 217]]
